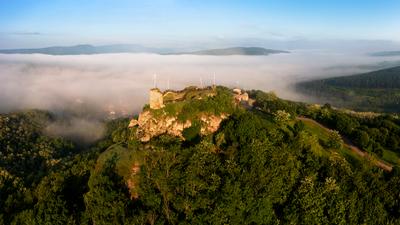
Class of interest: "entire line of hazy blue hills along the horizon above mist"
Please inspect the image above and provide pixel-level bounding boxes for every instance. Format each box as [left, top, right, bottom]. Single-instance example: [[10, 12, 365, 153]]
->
[[0, 45, 288, 55]]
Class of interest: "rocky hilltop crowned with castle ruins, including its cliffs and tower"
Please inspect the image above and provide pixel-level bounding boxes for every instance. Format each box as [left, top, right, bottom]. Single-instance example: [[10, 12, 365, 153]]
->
[[129, 87, 249, 142]]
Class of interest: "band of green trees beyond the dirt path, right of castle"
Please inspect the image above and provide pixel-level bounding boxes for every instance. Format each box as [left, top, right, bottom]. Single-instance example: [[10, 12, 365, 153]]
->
[[251, 91, 400, 165]]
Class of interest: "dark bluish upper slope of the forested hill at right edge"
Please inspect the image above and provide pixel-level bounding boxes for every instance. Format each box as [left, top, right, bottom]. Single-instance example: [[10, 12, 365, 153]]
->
[[309, 66, 400, 88]]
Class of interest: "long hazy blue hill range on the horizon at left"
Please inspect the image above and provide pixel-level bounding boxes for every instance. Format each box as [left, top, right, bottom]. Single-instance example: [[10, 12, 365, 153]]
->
[[0, 44, 171, 55]]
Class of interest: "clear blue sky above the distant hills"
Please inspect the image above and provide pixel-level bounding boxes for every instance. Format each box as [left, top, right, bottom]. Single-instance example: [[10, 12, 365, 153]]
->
[[0, 0, 400, 48]]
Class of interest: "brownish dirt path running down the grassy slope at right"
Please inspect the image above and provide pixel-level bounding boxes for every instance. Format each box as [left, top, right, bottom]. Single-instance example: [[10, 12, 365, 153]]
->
[[297, 117, 393, 172]]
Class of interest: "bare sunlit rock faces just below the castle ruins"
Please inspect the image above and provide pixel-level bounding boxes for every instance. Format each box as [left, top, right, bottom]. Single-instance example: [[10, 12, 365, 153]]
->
[[130, 111, 227, 142]]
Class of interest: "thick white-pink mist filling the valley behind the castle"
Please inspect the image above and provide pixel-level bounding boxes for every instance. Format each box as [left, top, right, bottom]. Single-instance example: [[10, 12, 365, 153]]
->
[[0, 51, 399, 140]]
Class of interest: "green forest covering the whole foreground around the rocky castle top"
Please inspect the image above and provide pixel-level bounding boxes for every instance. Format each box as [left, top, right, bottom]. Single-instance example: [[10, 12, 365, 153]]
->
[[0, 89, 400, 225]]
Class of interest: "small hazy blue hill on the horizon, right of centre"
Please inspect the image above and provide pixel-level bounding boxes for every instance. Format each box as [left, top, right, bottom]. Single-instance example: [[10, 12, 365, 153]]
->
[[167, 47, 289, 55]]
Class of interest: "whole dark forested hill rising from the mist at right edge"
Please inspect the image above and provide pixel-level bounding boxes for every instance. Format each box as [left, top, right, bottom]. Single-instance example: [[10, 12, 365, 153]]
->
[[296, 66, 400, 112]]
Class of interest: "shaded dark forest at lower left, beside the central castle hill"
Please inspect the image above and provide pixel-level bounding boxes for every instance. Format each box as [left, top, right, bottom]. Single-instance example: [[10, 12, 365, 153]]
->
[[0, 111, 115, 224]]
